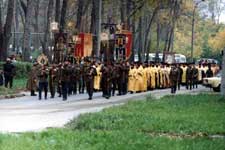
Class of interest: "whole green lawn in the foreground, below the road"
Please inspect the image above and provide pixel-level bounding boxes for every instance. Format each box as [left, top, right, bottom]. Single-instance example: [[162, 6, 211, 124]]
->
[[0, 95, 225, 150]]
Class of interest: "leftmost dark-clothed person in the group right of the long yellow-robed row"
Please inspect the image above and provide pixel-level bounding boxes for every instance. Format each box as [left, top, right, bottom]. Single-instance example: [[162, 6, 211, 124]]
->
[[170, 65, 179, 94]]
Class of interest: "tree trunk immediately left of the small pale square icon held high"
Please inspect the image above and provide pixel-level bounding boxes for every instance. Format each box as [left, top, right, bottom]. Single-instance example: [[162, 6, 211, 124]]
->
[[43, 0, 54, 57]]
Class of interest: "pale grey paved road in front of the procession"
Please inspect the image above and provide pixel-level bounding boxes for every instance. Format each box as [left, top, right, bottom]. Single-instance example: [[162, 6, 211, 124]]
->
[[0, 86, 209, 133]]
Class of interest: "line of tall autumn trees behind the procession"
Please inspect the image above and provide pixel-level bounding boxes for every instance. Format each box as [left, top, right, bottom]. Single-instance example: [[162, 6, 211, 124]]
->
[[0, 0, 224, 61]]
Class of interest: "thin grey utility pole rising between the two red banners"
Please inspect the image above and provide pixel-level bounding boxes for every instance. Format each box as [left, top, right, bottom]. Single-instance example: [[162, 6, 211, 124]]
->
[[96, 0, 102, 57]]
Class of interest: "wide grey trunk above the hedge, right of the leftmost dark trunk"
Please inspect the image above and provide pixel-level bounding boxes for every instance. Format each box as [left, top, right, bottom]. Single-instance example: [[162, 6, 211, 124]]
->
[[23, 0, 34, 61]]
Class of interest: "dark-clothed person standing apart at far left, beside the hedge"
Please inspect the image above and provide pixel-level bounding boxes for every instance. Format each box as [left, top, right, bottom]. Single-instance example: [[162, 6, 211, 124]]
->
[[3, 58, 16, 88]]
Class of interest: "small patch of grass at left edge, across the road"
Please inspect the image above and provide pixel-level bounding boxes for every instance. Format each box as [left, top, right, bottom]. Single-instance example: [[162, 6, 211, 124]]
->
[[0, 78, 27, 95]]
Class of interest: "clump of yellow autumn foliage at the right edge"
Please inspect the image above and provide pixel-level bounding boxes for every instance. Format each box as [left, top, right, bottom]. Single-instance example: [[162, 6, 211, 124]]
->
[[208, 30, 225, 52]]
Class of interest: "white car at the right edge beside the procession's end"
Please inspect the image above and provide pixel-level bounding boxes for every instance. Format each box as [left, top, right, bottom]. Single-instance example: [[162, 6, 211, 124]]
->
[[202, 71, 222, 92]]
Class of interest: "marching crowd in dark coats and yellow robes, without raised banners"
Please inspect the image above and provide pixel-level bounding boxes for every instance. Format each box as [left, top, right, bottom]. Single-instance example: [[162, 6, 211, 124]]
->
[[27, 59, 219, 100]]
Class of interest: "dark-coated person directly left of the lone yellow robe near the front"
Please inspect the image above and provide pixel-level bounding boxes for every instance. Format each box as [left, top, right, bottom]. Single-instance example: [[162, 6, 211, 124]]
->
[[86, 64, 97, 100]]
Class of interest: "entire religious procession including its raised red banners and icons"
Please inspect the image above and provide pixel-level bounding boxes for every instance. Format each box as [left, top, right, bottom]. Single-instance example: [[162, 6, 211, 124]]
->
[[27, 25, 219, 100]]
